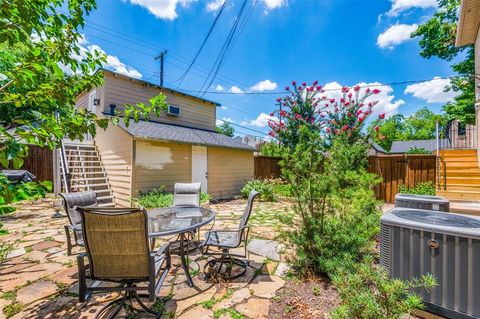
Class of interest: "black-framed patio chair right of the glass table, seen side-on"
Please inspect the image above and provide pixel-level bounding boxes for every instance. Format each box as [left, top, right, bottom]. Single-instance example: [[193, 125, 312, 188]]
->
[[201, 190, 260, 279]]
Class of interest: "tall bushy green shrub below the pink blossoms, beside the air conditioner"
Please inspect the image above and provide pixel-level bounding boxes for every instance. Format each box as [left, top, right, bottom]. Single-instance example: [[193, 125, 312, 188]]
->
[[280, 131, 380, 276]]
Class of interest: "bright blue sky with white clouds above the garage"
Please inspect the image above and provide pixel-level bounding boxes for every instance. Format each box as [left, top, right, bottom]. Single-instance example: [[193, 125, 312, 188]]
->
[[83, 0, 460, 135]]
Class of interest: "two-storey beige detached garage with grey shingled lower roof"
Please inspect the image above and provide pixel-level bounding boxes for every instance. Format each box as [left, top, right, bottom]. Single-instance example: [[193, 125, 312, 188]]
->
[[73, 70, 255, 206]]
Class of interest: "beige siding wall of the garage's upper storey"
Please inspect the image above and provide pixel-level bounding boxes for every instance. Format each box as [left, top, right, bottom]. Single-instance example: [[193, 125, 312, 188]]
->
[[102, 73, 216, 130]]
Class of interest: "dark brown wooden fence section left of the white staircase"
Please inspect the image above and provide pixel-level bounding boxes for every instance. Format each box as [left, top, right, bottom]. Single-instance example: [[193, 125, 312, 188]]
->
[[0, 145, 54, 182]]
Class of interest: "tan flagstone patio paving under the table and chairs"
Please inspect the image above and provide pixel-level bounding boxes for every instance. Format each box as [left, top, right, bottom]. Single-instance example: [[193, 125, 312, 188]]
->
[[0, 197, 290, 319]]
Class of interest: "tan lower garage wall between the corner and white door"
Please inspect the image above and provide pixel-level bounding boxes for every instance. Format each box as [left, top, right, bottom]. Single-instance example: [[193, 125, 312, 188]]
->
[[133, 140, 192, 195]]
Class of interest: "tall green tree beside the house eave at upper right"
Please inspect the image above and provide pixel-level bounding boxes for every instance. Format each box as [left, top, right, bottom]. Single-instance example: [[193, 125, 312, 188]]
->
[[412, 0, 475, 124]]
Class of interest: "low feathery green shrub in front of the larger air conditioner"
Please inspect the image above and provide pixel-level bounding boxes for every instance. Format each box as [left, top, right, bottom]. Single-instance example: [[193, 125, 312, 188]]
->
[[331, 257, 436, 319]]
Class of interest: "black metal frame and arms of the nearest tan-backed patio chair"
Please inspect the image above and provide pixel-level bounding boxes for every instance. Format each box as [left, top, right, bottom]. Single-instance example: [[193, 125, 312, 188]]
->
[[77, 207, 171, 319]]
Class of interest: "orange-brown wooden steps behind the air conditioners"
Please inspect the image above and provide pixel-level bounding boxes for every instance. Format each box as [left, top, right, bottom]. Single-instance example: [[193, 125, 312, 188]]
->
[[437, 149, 480, 201]]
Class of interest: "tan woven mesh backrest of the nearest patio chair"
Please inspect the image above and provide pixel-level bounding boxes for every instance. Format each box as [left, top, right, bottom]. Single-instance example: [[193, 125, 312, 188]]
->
[[78, 207, 150, 280]]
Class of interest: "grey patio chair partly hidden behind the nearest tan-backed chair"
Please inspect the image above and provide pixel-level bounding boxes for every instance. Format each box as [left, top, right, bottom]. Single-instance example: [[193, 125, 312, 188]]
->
[[60, 191, 98, 256]]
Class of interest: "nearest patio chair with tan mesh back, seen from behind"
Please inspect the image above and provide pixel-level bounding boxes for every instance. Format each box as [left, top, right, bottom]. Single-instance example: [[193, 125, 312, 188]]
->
[[77, 207, 171, 318]]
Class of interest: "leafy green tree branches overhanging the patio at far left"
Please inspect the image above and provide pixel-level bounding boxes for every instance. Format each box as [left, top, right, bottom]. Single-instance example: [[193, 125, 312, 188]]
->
[[0, 0, 166, 215]]
